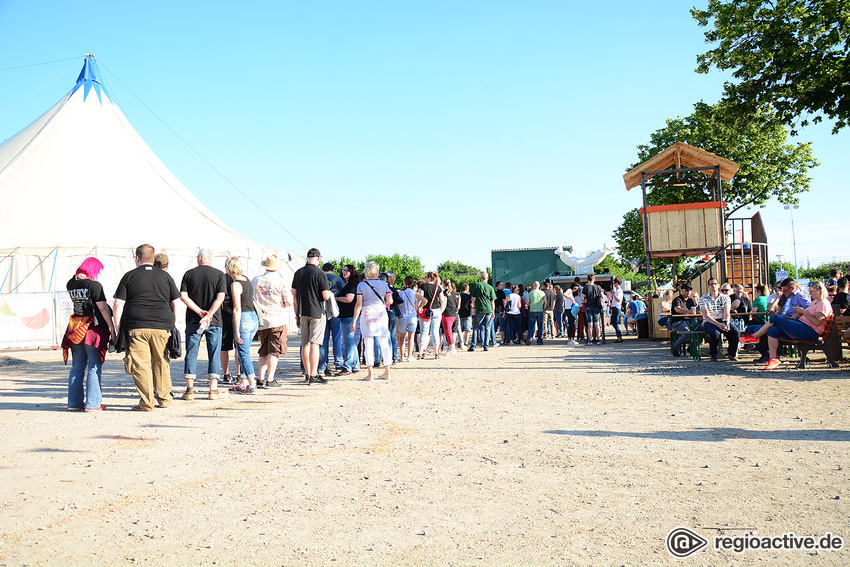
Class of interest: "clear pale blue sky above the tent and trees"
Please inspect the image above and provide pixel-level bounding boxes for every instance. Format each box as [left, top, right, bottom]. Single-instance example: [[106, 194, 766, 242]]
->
[[0, 0, 850, 269]]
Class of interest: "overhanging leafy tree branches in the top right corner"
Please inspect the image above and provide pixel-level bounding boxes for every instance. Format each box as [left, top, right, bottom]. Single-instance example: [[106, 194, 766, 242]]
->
[[691, 0, 850, 133]]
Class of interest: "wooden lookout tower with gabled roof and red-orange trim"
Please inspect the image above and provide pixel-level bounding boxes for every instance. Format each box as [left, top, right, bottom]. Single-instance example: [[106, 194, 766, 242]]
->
[[623, 142, 768, 302]]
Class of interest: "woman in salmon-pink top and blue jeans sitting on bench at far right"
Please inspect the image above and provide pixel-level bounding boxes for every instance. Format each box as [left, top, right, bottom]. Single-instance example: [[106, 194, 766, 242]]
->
[[741, 281, 832, 370]]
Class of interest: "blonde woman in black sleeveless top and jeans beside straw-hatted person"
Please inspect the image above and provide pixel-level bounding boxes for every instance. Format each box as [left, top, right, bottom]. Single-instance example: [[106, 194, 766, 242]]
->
[[224, 256, 259, 394]]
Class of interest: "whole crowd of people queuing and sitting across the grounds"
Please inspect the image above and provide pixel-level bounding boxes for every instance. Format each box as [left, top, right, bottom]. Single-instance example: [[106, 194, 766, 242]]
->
[[62, 244, 850, 411]]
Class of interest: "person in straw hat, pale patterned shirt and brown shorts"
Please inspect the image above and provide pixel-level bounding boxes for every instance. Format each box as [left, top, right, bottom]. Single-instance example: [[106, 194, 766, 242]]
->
[[251, 254, 292, 388]]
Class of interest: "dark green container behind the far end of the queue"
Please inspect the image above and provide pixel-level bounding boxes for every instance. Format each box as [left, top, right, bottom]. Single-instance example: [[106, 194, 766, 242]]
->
[[490, 246, 573, 285]]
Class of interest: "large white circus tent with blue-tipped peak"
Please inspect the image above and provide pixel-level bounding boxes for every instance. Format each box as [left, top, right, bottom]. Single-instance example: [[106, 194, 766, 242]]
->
[[0, 55, 304, 348]]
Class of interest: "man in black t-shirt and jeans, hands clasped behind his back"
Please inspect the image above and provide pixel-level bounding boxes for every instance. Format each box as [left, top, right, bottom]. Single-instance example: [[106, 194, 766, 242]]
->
[[180, 248, 227, 401]]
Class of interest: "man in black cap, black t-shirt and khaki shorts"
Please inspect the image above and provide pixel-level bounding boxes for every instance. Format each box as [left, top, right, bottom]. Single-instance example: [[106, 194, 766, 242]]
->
[[292, 248, 333, 384]]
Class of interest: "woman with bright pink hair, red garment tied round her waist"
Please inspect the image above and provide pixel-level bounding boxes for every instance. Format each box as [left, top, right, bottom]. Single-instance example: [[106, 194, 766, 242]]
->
[[62, 258, 115, 412]]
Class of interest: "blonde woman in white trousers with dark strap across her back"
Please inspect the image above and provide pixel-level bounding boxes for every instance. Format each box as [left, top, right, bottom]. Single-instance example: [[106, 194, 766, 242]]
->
[[351, 262, 393, 382]]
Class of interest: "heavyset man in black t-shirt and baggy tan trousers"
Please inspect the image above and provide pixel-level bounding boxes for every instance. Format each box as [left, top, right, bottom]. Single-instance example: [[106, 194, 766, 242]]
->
[[113, 244, 180, 411]]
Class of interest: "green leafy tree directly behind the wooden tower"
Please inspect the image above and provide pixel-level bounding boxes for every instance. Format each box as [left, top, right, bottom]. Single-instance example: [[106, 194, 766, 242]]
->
[[614, 102, 818, 261]]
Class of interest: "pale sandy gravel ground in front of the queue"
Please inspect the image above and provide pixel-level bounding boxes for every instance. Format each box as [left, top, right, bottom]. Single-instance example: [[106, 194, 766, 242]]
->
[[0, 338, 850, 566]]
